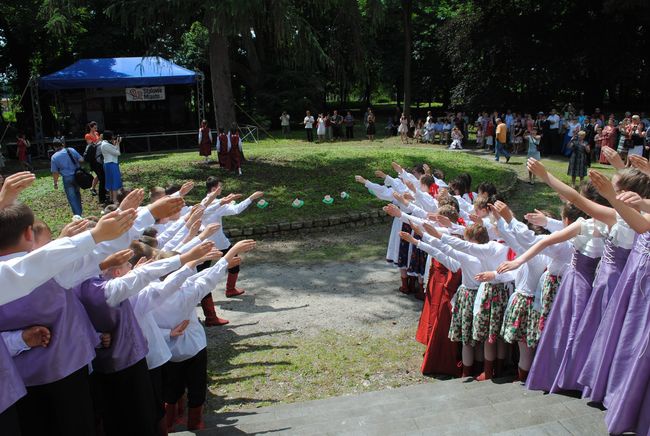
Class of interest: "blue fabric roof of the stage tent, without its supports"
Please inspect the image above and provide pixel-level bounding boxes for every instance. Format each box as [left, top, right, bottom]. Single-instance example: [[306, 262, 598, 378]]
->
[[39, 57, 197, 89]]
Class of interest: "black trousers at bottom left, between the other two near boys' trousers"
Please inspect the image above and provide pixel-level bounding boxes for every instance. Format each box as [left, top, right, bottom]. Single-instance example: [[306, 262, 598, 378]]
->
[[91, 359, 159, 436]]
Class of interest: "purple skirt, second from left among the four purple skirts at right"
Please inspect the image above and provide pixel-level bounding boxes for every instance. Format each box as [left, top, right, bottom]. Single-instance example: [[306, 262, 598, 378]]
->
[[557, 241, 630, 391]]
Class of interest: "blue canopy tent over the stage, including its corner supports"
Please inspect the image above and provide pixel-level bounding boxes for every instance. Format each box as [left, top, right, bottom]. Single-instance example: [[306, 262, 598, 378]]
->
[[31, 57, 205, 153]]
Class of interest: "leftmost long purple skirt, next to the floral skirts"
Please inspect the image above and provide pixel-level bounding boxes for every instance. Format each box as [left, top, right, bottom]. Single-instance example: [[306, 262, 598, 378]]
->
[[526, 251, 599, 392]]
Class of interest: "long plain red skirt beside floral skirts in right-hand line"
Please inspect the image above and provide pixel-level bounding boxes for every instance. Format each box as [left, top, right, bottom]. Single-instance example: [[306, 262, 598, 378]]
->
[[418, 260, 462, 377]]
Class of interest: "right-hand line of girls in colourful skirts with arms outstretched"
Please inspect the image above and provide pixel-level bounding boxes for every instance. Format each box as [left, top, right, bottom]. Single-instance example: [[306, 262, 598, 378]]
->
[[355, 150, 650, 434]]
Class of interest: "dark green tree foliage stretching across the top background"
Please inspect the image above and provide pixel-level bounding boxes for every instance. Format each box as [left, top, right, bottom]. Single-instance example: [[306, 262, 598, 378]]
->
[[0, 0, 650, 131]]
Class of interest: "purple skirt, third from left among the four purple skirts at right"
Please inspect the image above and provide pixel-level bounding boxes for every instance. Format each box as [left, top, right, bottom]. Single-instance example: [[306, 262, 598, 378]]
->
[[578, 234, 647, 402]]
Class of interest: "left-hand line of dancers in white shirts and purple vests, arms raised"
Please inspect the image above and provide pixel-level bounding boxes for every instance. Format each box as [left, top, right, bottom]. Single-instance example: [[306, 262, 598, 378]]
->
[[0, 172, 263, 436]]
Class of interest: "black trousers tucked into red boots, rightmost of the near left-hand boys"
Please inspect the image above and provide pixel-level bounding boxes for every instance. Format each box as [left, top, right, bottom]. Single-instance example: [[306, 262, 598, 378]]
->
[[163, 348, 208, 408]]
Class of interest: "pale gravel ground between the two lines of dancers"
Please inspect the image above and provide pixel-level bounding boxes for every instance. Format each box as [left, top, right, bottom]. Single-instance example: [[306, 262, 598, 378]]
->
[[204, 261, 422, 345]]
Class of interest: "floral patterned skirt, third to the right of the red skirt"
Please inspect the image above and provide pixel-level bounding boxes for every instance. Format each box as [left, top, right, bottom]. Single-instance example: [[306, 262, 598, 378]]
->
[[501, 292, 539, 348]]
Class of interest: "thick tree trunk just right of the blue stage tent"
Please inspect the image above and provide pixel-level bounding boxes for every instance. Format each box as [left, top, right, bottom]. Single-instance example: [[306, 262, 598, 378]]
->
[[208, 32, 237, 129]]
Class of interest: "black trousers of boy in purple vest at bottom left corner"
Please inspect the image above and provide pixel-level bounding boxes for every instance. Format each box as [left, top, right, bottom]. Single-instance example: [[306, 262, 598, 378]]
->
[[16, 366, 95, 436]]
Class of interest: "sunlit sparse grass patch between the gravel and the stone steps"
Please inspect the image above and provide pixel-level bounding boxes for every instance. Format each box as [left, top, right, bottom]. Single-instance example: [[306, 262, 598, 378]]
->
[[208, 326, 427, 411]]
